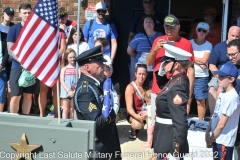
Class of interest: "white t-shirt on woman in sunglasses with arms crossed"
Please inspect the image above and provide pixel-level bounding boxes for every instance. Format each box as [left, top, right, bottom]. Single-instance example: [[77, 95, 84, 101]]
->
[[190, 39, 212, 77]]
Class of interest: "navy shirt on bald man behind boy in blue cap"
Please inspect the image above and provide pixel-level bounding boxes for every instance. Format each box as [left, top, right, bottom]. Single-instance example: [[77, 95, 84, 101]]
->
[[208, 41, 229, 69]]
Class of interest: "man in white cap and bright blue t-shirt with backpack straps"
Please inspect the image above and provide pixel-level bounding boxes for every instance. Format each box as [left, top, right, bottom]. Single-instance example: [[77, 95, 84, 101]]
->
[[83, 2, 118, 61]]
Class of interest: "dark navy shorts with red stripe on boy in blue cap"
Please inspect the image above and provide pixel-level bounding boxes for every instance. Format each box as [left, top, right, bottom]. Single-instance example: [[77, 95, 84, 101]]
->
[[213, 143, 234, 160]]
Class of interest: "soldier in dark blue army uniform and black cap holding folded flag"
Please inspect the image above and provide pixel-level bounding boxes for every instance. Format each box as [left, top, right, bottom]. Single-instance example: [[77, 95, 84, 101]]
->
[[74, 46, 121, 160]]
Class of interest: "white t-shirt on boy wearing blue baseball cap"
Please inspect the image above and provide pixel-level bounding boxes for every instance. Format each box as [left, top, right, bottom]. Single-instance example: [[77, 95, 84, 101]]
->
[[211, 88, 240, 147]]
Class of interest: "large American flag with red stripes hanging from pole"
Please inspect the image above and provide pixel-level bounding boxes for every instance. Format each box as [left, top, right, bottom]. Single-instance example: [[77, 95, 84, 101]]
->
[[11, 0, 60, 87]]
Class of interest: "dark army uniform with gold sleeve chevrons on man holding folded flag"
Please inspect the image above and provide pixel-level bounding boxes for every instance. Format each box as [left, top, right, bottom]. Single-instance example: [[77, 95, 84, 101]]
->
[[74, 73, 121, 160]]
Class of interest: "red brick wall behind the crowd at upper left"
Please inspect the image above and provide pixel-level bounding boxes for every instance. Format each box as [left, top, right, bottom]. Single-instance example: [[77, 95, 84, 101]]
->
[[0, 0, 110, 25]]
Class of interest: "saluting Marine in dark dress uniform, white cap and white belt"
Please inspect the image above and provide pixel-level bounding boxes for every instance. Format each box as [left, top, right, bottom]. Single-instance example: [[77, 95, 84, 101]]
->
[[153, 44, 193, 160]]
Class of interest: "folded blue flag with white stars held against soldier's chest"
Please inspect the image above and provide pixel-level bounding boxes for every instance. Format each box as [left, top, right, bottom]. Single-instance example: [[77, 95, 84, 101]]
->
[[102, 77, 112, 118]]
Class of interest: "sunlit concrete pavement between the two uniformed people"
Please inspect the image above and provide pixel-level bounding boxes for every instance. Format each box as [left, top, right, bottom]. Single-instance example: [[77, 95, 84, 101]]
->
[[117, 109, 153, 160]]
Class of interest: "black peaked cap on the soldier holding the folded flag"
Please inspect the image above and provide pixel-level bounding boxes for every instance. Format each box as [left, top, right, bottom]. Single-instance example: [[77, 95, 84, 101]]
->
[[75, 46, 107, 65]]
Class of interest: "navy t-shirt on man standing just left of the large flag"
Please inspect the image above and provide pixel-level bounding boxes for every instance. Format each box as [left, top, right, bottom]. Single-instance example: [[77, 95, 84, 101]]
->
[[7, 23, 23, 69]]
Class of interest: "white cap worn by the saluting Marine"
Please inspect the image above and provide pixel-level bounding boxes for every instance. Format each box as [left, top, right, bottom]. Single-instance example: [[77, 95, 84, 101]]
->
[[163, 44, 192, 61]]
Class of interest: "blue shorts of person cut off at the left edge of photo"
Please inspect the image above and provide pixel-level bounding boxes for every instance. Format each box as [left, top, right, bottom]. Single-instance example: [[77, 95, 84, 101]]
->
[[0, 70, 7, 104]]
